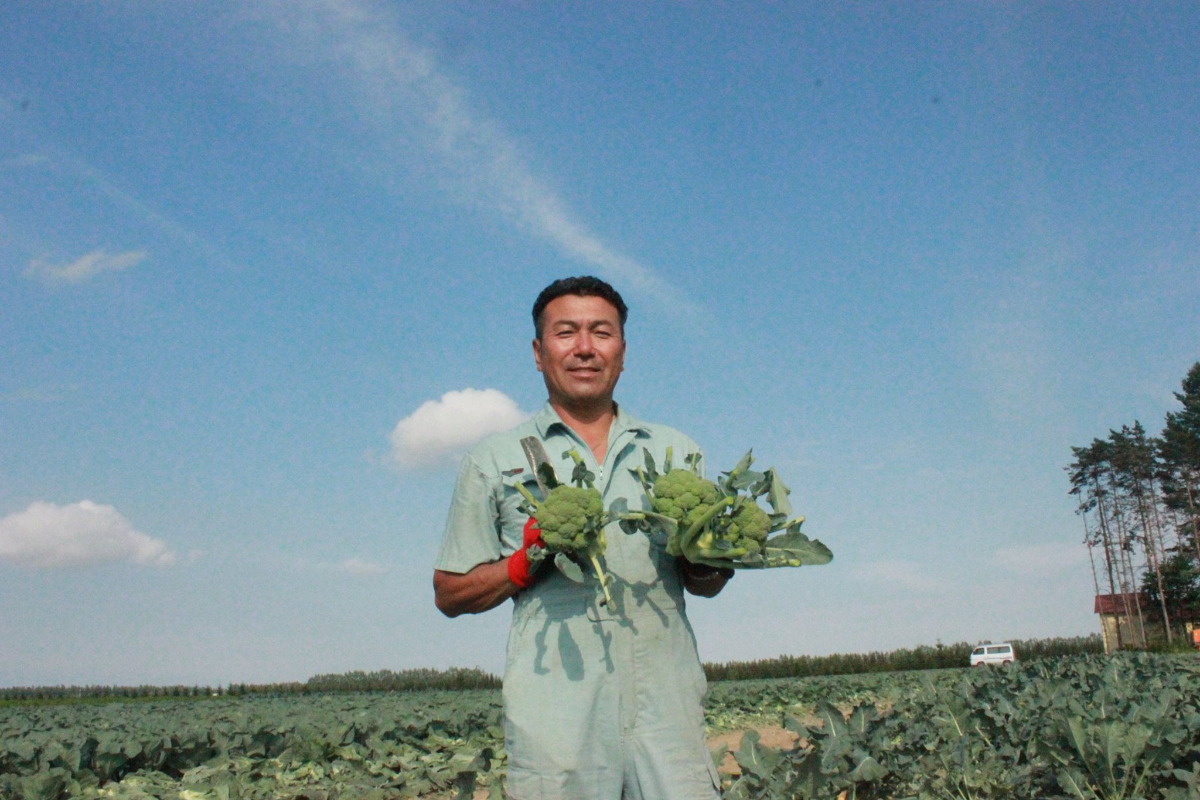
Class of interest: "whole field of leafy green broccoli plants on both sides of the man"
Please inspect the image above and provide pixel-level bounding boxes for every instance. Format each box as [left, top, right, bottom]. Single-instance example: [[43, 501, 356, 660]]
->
[[0, 654, 1200, 800]]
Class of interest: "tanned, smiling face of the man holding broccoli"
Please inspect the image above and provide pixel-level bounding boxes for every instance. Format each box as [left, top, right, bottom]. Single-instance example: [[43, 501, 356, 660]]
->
[[533, 295, 625, 408]]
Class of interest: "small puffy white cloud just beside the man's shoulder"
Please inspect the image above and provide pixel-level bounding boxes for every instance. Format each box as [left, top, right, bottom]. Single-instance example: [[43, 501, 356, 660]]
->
[[391, 389, 530, 469]]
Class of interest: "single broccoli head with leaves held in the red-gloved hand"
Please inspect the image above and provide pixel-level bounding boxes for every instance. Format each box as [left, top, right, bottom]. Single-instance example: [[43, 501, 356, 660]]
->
[[514, 450, 612, 604]]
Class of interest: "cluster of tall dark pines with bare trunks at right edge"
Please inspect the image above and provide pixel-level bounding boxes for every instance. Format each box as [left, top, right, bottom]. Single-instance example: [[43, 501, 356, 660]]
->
[[1067, 362, 1200, 649]]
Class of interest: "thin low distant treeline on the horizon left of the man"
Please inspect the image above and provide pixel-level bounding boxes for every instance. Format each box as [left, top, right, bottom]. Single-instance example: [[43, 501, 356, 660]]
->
[[0, 667, 500, 702]]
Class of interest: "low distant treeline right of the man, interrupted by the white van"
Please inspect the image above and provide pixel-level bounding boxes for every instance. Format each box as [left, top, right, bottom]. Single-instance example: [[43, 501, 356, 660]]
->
[[704, 634, 1104, 681]]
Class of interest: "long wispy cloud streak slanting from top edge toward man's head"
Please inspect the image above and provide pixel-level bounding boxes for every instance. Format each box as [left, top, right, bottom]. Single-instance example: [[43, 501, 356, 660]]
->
[[262, 0, 694, 309]]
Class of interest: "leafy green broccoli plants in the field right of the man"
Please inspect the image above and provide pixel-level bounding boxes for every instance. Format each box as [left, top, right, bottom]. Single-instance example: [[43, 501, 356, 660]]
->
[[725, 654, 1200, 800]]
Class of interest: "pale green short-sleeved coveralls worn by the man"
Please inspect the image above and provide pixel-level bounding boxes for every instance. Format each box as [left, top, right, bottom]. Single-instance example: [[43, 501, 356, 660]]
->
[[434, 403, 720, 800]]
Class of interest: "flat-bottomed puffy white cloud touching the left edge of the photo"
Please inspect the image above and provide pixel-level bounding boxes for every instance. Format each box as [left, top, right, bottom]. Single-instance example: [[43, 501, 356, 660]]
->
[[0, 500, 175, 567]]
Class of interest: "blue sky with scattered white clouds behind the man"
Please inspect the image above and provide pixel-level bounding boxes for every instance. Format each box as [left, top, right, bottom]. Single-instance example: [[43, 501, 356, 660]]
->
[[0, 0, 1200, 685]]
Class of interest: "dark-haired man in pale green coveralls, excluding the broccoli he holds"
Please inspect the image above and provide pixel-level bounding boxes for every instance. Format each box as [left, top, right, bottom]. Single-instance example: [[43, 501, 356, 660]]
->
[[433, 277, 732, 800]]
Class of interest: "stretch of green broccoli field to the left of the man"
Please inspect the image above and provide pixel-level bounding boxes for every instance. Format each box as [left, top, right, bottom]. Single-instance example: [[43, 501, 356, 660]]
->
[[0, 691, 505, 800]]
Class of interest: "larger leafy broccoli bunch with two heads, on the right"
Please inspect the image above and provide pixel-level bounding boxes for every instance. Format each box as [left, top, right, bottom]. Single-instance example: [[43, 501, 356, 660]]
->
[[610, 449, 833, 569]]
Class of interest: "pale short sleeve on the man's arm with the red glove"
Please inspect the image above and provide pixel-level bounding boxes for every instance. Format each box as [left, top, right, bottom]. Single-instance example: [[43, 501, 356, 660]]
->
[[433, 456, 500, 573]]
